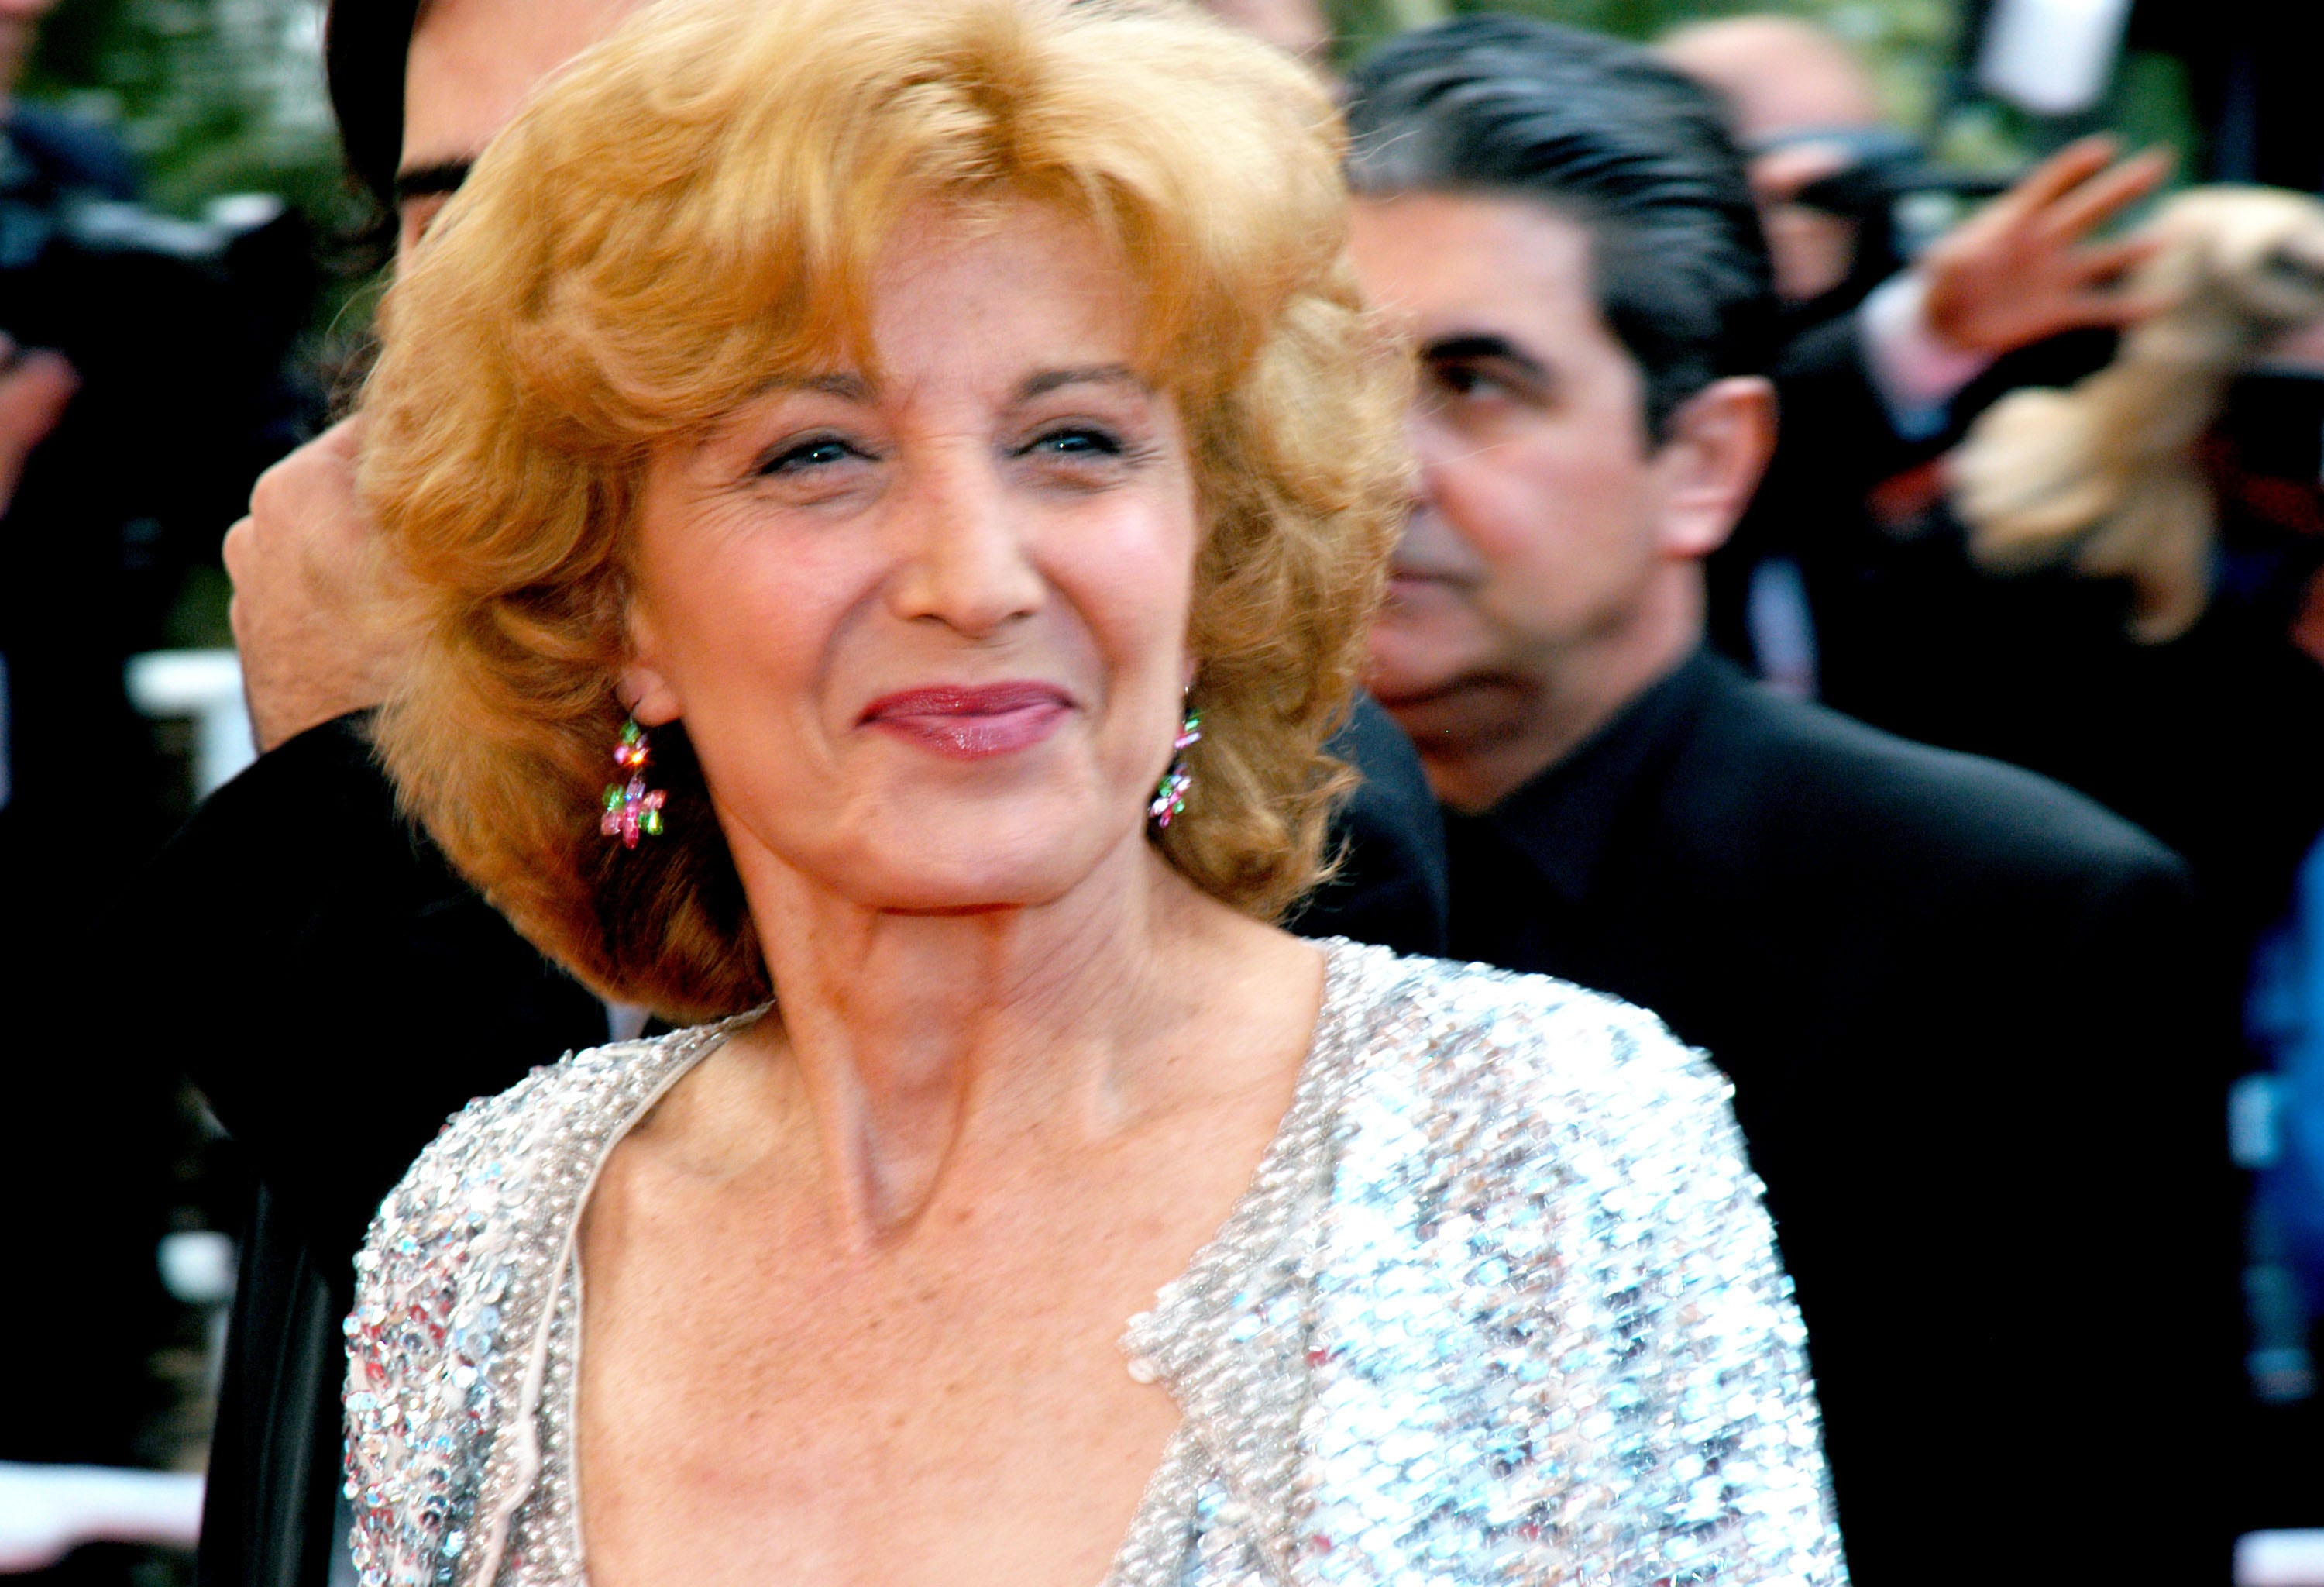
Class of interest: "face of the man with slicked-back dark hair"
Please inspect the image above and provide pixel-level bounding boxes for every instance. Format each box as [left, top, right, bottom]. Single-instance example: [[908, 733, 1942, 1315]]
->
[[1350, 193, 1692, 771]]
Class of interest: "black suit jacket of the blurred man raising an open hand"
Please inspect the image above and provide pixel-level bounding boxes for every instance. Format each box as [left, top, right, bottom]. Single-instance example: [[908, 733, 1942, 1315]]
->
[[1713, 316, 2324, 980]]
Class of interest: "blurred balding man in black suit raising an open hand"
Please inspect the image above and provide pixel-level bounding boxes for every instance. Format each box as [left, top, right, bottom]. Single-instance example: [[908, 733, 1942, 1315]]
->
[[1657, 5, 2324, 1166]]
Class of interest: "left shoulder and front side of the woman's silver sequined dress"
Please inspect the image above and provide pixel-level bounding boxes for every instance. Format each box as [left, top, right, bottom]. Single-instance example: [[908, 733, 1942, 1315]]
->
[[346, 1020, 737, 1587]]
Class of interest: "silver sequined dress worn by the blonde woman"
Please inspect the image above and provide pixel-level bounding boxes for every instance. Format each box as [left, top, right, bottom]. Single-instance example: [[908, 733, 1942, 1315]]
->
[[346, 943, 1845, 1587]]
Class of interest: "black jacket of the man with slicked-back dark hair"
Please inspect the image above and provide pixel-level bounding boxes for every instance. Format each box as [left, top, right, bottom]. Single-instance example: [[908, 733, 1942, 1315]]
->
[[1448, 656, 2231, 1587]]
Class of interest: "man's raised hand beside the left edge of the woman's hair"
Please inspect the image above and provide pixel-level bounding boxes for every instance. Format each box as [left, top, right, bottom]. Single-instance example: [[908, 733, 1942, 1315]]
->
[[225, 414, 409, 751]]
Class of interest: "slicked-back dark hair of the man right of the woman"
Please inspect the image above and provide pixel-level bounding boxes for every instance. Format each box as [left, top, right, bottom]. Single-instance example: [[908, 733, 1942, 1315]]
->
[[1348, 16, 1776, 439]]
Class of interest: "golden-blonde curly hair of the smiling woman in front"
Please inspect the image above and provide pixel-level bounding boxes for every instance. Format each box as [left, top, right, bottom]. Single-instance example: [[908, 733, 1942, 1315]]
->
[[360, 0, 1404, 1017]]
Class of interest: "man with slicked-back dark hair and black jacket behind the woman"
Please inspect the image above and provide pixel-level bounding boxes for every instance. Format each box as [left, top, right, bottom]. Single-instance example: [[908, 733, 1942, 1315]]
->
[[1350, 16, 2229, 1587]]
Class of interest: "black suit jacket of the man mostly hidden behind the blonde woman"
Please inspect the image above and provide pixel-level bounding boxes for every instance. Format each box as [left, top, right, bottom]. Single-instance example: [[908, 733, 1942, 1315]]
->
[[150, 700, 1446, 1587]]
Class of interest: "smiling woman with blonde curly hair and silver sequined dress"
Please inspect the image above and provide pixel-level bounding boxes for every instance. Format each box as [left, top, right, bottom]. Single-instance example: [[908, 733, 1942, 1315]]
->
[[346, 0, 1841, 1587]]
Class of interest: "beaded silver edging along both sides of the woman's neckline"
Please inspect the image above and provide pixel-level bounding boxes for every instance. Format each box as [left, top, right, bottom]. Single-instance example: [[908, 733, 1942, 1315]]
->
[[518, 938, 1367, 1587]]
